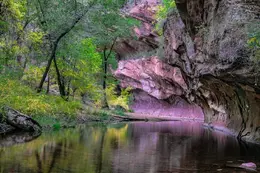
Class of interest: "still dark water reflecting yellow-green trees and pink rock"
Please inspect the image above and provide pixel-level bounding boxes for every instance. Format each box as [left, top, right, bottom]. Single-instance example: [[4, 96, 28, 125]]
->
[[0, 122, 260, 173]]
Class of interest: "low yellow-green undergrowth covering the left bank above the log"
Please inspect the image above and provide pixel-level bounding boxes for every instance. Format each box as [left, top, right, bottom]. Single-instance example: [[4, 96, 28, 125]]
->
[[0, 76, 81, 116]]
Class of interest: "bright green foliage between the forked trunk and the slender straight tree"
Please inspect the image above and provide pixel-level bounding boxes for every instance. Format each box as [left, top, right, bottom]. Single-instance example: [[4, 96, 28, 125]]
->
[[57, 38, 102, 104]]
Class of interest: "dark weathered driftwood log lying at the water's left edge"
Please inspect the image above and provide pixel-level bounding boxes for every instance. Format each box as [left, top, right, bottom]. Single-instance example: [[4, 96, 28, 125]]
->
[[4, 106, 42, 132]]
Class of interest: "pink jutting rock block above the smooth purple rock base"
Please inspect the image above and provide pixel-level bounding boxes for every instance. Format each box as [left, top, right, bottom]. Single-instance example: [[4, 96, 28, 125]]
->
[[114, 56, 187, 99]]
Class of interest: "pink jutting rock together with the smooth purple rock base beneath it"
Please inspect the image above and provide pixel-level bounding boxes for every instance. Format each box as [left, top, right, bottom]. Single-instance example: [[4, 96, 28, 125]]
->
[[114, 57, 204, 120]]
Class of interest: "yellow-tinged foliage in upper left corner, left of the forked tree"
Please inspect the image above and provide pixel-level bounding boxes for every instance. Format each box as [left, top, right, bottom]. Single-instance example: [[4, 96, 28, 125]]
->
[[0, 0, 44, 75]]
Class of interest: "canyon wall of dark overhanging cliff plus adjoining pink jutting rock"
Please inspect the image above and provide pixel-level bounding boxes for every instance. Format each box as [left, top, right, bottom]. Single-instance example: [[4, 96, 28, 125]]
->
[[115, 0, 260, 143]]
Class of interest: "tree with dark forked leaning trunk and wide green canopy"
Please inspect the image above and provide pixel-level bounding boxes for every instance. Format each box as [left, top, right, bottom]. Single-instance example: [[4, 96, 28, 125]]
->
[[33, 0, 136, 102]]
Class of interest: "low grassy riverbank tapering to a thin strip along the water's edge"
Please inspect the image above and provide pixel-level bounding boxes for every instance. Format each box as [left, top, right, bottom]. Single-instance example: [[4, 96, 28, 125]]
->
[[0, 107, 203, 134]]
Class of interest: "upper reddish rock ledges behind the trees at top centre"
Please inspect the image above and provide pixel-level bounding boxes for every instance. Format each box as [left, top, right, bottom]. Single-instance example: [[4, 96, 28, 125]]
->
[[114, 0, 161, 60]]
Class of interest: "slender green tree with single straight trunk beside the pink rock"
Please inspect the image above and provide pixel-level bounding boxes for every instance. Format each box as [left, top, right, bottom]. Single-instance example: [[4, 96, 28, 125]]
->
[[88, 6, 139, 108]]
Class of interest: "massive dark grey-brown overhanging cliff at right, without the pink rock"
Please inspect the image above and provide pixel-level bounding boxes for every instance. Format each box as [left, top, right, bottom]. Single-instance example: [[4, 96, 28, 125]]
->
[[164, 0, 260, 142]]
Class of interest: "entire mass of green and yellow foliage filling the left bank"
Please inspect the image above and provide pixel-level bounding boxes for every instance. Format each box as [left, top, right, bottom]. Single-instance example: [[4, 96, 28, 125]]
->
[[0, 0, 136, 121]]
